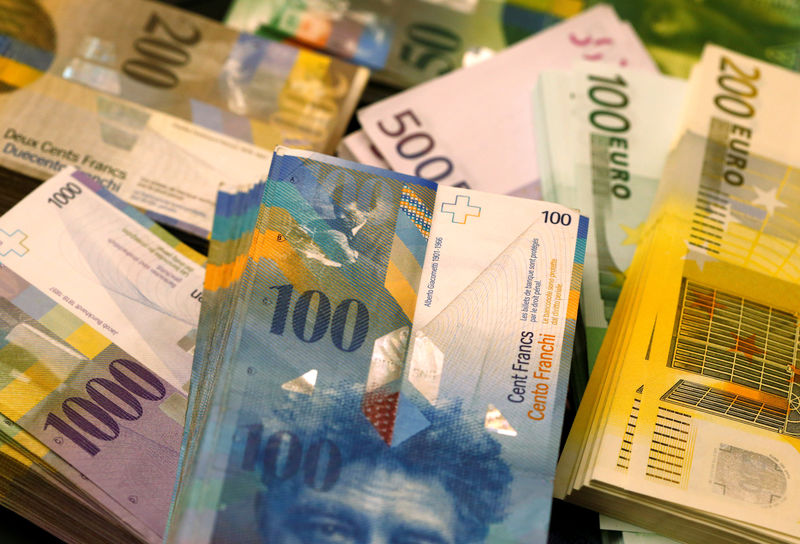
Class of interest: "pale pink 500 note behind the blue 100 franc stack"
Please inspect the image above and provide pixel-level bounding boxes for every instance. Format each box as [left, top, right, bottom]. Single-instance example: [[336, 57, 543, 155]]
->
[[358, 6, 656, 198]]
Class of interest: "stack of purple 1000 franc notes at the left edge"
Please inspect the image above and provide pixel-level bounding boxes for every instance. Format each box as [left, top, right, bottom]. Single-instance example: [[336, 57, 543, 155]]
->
[[0, 168, 205, 544]]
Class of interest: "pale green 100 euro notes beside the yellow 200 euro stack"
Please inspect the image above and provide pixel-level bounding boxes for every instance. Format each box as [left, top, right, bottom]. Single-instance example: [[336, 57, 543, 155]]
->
[[537, 64, 685, 370]]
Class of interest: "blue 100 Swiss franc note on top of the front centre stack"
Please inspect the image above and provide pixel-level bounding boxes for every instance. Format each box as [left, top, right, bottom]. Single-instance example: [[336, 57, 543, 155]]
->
[[168, 150, 586, 542]]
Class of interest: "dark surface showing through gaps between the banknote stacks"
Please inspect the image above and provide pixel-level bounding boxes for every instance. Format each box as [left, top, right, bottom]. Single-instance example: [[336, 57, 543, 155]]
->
[[0, 0, 601, 544]]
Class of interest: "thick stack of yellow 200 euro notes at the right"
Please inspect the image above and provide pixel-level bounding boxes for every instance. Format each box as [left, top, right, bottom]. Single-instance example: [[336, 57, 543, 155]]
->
[[556, 45, 800, 542]]
